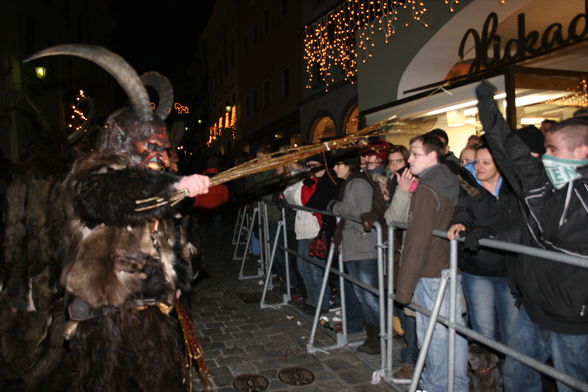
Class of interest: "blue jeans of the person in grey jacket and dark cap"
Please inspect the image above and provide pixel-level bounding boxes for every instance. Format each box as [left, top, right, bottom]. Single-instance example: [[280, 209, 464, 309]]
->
[[345, 259, 380, 326]]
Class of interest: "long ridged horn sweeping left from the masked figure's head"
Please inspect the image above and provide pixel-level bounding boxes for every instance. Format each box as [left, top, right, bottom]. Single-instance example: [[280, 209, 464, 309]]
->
[[23, 44, 153, 121]]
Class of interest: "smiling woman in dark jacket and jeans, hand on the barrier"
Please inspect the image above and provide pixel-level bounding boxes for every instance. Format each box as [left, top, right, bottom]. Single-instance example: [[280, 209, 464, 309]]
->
[[448, 145, 520, 350]]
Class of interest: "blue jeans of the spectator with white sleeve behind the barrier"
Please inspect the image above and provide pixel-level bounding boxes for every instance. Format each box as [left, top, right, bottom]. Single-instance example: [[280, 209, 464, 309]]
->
[[297, 239, 330, 310]]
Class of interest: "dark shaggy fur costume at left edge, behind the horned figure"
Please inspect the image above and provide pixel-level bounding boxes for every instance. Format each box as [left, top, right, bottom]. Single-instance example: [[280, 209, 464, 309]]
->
[[0, 144, 73, 390]]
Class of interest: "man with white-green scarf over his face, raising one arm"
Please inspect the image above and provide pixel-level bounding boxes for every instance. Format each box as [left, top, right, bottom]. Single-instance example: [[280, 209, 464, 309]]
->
[[476, 82, 588, 392]]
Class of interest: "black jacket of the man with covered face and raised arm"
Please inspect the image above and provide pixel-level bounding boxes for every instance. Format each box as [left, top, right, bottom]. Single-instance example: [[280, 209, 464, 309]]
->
[[476, 82, 588, 334]]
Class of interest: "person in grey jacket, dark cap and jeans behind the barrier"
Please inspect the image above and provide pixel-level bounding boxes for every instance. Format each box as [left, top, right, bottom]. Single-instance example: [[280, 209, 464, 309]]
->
[[329, 150, 380, 354]]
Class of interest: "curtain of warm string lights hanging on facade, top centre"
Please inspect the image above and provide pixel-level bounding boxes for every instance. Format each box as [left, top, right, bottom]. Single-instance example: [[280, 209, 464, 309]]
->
[[304, 0, 505, 90]]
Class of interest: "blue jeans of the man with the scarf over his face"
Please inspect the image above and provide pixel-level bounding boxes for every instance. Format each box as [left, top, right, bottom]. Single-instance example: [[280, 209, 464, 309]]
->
[[504, 306, 588, 392]]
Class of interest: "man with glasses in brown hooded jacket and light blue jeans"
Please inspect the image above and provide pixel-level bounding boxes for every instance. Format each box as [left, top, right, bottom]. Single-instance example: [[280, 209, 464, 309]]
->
[[396, 134, 469, 392]]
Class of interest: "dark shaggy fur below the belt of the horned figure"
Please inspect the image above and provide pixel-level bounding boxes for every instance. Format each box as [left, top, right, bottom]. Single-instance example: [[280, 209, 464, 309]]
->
[[70, 304, 184, 392]]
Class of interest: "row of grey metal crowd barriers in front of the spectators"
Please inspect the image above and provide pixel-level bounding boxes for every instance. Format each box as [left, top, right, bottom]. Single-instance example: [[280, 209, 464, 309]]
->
[[238, 203, 588, 392]]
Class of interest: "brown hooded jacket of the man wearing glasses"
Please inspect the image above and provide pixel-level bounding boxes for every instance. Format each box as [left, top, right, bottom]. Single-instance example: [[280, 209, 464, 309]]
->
[[396, 164, 459, 304]]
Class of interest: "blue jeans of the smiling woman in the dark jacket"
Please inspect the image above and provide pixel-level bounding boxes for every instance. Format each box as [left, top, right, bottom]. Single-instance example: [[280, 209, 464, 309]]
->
[[463, 273, 518, 345]]
